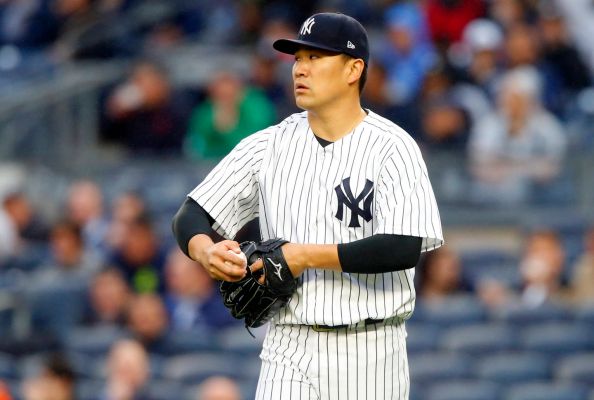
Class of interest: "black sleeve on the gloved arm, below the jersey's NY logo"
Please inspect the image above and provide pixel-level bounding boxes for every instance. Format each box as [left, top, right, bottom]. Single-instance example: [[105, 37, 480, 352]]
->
[[338, 235, 423, 274]]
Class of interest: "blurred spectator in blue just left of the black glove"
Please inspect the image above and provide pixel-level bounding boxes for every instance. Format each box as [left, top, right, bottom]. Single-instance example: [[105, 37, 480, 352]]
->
[[165, 247, 237, 331]]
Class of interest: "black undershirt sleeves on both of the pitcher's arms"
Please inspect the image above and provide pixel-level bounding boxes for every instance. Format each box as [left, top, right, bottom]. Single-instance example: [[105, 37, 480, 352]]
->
[[172, 195, 422, 274]]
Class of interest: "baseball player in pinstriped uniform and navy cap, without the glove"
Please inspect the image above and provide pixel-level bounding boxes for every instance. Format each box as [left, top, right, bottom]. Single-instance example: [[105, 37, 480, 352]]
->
[[173, 13, 443, 400]]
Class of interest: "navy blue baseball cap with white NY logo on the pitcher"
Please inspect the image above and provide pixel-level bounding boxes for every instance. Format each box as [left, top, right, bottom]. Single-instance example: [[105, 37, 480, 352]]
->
[[272, 13, 369, 64]]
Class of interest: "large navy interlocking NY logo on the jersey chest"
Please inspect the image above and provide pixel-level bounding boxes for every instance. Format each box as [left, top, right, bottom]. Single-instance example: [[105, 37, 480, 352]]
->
[[334, 177, 373, 228]]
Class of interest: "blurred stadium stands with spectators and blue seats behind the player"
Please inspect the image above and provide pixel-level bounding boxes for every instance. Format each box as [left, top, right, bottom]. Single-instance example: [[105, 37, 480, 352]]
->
[[0, 0, 594, 400]]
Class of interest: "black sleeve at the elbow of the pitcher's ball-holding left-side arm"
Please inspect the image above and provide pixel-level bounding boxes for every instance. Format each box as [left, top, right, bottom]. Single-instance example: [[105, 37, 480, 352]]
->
[[171, 197, 214, 257]]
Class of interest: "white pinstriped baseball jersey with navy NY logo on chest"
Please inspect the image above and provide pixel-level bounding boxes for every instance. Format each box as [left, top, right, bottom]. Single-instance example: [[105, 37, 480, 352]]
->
[[190, 111, 443, 325]]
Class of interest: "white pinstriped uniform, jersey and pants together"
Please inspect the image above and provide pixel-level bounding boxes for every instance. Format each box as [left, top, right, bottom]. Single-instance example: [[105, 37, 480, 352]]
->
[[189, 112, 443, 400]]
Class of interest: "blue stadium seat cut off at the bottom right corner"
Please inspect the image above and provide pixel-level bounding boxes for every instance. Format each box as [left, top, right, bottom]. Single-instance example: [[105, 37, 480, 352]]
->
[[505, 383, 588, 400]]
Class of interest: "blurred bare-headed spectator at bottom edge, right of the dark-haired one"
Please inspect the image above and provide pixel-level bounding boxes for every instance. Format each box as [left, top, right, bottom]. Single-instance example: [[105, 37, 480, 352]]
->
[[99, 339, 149, 400]]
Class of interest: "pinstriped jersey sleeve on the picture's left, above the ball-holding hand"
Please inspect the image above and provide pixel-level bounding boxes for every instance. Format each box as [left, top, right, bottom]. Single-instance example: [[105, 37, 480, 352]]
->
[[188, 130, 272, 239]]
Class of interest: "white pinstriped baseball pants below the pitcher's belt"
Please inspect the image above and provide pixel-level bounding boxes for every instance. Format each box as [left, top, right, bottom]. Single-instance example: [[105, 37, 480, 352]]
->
[[256, 322, 410, 400]]
